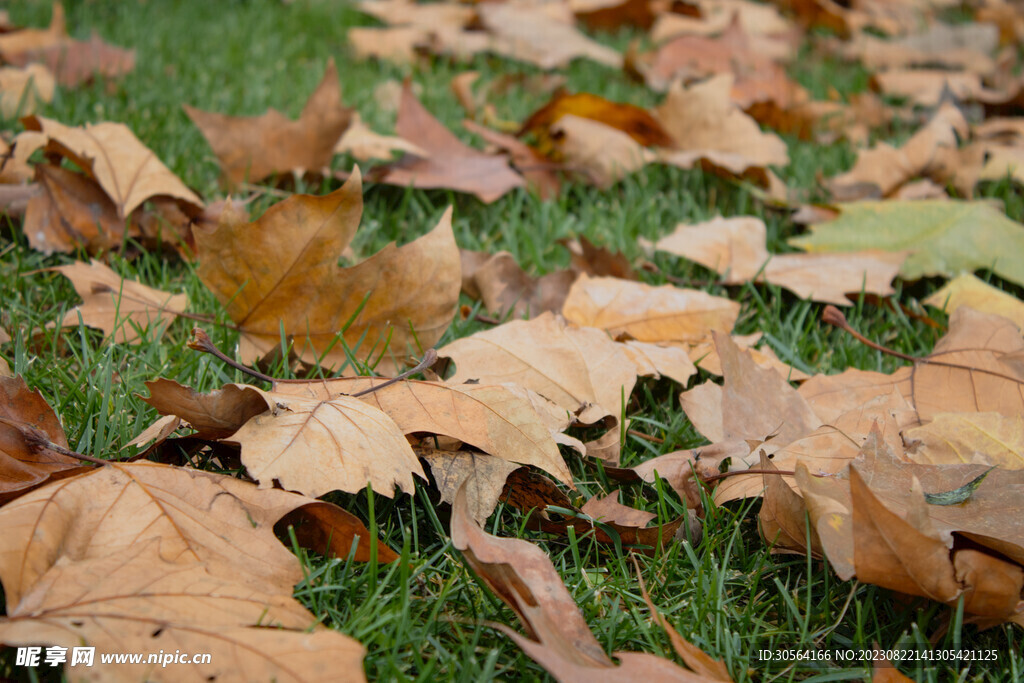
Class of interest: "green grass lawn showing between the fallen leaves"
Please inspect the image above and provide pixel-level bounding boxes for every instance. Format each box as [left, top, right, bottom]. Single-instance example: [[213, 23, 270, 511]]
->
[[0, 0, 1024, 682]]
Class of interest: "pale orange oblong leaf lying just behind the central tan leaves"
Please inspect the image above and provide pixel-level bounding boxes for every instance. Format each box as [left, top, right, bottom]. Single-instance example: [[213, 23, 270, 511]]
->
[[562, 274, 739, 342]]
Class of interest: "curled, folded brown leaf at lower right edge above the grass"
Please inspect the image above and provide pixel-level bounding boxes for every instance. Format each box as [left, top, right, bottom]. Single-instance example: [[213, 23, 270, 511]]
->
[[797, 438, 1024, 622]]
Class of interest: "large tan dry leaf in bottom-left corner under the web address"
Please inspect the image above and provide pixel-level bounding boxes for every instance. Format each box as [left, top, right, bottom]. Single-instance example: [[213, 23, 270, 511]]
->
[[0, 539, 365, 683]]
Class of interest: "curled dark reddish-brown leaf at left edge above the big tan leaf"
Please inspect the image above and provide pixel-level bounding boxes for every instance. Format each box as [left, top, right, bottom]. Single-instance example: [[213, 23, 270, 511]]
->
[[0, 377, 89, 505]]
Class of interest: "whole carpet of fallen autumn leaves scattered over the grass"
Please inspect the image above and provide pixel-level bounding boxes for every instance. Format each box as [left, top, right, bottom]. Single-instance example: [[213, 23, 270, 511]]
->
[[0, 0, 1024, 681]]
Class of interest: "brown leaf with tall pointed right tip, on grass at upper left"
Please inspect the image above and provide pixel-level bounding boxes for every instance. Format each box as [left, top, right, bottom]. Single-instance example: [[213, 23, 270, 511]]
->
[[183, 59, 352, 185]]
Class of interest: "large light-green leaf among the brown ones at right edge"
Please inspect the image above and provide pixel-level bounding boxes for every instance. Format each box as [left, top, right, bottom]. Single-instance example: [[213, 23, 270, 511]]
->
[[790, 200, 1024, 285]]
